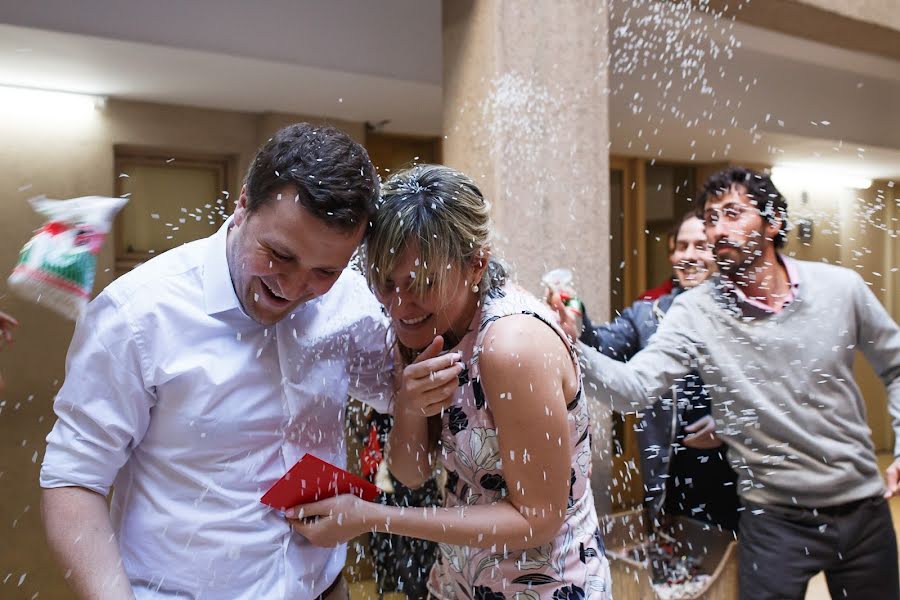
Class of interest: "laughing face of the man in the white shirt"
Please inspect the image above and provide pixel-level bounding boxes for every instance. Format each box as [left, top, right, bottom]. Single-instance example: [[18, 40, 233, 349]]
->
[[227, 185, 365, 325]]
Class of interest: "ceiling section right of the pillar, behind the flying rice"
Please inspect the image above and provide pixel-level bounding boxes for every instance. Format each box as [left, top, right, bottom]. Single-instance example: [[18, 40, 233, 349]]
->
[[609, 0, 900, 179]]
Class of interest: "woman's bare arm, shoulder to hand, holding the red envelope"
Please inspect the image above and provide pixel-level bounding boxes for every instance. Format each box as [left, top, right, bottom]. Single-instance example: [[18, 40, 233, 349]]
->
[[296, 315, 578, 550]]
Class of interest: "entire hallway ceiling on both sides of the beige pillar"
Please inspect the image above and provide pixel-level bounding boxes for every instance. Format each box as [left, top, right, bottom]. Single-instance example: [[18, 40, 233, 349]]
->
[[0, 0, 900, 178]]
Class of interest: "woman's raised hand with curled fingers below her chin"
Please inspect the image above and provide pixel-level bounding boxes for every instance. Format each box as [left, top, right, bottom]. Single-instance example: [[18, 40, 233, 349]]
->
[[396, 336, 463, 417]]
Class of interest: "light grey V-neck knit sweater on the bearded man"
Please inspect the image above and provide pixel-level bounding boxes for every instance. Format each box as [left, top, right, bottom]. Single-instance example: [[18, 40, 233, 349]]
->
[[579, 261, 900, 507]]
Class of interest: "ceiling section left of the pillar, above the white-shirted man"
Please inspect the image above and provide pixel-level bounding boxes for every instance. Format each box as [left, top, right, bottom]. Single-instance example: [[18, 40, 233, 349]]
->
[[0, 0, 441, 135]]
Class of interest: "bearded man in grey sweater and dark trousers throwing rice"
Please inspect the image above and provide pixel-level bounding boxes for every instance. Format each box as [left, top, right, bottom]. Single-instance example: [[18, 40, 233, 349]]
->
[[579, 168, 900, 600]]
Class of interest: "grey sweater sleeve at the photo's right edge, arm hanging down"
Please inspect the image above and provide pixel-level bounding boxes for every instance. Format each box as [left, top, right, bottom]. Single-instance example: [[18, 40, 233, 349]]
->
[[853, 273, 900, 458]]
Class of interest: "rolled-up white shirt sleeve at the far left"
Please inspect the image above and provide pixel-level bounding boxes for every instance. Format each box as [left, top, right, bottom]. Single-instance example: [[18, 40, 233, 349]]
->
[[40, 293, 156, 496]]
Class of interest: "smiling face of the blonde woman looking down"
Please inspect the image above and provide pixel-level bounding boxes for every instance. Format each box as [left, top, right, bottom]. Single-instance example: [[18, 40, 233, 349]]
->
[[377, 243, 487, 350]]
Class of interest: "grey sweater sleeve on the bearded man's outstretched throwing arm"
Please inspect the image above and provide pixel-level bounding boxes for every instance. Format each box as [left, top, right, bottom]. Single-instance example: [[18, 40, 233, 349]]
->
[[578, 299, 700, 413]]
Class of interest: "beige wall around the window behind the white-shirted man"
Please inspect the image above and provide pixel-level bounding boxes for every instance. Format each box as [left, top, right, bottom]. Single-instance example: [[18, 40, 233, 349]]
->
[[0, 96, 365, 599]]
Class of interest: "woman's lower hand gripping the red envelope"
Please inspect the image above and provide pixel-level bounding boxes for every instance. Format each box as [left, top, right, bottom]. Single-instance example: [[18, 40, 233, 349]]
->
[[284, 494, 378, 548]]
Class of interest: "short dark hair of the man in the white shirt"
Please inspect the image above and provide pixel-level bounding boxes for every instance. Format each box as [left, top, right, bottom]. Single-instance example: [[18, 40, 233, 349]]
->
[[244, 123, 379, 231]]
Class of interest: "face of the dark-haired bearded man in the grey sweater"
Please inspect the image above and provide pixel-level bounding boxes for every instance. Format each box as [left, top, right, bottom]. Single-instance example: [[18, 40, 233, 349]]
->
[[703, 185, 778, 274]]
